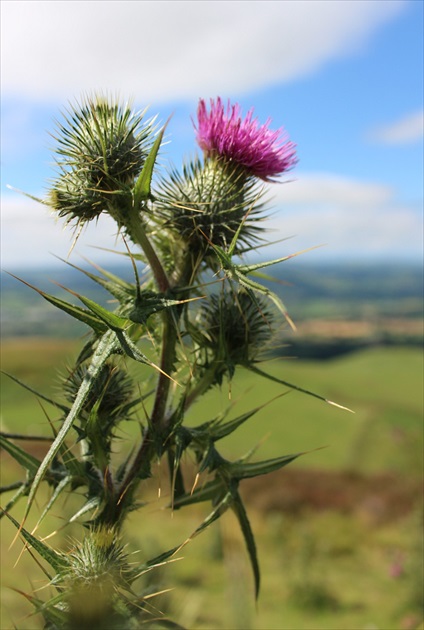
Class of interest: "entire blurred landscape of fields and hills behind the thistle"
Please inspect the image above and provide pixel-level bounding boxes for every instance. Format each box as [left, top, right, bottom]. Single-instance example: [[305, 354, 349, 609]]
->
[[0, 262, 424, 630]]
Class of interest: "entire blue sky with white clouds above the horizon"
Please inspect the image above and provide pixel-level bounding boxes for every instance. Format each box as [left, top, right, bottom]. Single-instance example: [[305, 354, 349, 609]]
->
[[1, 0, 424, 271]]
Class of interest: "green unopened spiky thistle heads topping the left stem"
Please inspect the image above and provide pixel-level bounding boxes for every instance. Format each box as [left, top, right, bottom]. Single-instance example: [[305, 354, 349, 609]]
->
[[47, 97, 153, 225]]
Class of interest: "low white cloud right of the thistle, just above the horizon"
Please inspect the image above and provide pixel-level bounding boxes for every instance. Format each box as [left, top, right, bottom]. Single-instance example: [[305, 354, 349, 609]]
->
[[268, 174, 423, 260]]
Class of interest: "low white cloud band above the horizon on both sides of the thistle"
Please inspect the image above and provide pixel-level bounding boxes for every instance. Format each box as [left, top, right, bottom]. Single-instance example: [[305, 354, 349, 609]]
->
[[2, 173, 423, 271]]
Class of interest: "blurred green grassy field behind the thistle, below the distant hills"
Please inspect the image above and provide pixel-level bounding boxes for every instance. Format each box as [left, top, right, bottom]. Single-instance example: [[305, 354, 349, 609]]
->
[[1, 339, 423, 630]]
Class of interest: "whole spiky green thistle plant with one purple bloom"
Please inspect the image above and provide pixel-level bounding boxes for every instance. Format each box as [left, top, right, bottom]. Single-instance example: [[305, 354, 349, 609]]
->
[[1, 96, 348, 630]]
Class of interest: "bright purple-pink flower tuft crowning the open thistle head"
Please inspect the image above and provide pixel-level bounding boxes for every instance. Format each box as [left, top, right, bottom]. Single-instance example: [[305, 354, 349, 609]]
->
[[194, 97, 297, 181]]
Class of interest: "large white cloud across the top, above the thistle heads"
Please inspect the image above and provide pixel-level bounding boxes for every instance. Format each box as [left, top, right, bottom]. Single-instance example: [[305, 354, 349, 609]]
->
[[1, 0, 405, 103]]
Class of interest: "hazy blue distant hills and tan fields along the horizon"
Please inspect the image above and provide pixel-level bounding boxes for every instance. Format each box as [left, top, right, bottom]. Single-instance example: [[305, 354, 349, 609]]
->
[[1, 260, 423, 354]]
